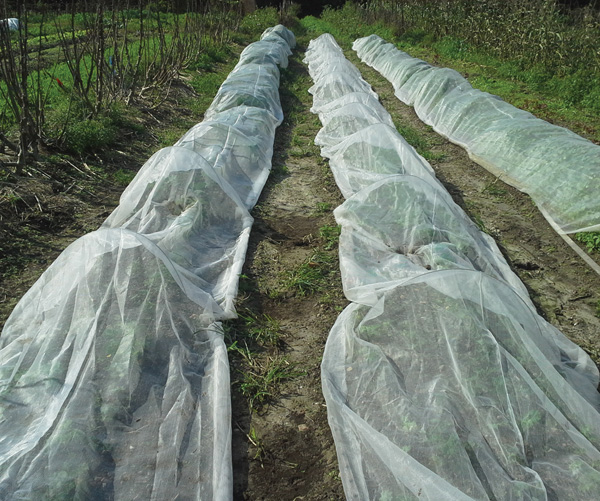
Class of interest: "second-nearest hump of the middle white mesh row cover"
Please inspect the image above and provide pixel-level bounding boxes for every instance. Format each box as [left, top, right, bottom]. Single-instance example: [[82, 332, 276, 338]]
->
[[335, 175, 533, 308]]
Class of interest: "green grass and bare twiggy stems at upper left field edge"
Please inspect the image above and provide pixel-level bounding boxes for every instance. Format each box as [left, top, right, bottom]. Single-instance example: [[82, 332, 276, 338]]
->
[[0, 0, 247, 173]]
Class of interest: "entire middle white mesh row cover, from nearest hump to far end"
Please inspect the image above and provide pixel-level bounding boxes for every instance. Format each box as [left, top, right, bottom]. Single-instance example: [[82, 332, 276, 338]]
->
[[306, 35, 600, 501]]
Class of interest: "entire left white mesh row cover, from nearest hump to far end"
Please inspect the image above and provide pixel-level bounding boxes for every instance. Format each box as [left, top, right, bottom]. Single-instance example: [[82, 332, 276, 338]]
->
[[0, 27, 293, 501]]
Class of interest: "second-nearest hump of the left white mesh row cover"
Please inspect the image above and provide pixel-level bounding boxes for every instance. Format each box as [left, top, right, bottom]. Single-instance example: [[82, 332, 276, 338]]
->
[[103, 144, 253, 312]]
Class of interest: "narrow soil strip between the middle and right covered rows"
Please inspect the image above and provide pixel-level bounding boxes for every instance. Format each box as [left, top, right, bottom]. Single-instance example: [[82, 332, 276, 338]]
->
[[346, 50, 600, 365]]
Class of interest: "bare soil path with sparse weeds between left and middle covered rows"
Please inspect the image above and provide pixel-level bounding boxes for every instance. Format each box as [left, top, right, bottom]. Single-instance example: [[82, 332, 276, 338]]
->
[[227, 47, 347, 501]]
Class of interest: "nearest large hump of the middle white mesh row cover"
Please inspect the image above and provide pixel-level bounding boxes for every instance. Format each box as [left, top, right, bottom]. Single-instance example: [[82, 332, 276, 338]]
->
[[322, 270, 600, 501]]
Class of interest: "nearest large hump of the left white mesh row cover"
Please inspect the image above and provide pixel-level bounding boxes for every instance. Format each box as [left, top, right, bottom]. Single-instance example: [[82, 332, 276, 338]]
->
[[0, 229, 231, 500]]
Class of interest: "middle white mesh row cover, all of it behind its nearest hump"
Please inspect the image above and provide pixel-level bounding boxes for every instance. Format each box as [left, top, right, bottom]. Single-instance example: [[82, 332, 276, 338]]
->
[[306, 34, 531, 304]]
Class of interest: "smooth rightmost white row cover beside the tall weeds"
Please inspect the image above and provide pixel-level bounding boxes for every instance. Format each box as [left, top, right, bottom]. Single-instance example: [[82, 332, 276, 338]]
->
[[353, 35, 600, 233]]
